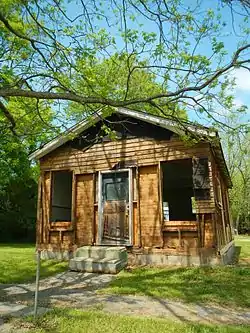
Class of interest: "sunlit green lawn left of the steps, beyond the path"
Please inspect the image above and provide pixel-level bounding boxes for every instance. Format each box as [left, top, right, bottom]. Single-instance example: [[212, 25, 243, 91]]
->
[[0, 244, 68, 283]]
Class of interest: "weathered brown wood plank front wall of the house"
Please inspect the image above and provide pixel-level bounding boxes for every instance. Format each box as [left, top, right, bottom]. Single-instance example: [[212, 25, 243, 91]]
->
[[36, 138, 227, 247]]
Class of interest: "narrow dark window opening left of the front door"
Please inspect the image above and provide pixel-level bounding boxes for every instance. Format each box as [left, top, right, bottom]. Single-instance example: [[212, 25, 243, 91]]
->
[[50, 171, 72, 222]]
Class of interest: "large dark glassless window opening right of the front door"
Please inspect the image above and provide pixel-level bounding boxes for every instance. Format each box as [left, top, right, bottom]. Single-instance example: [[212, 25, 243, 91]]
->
[[161, 158, 210, 221]]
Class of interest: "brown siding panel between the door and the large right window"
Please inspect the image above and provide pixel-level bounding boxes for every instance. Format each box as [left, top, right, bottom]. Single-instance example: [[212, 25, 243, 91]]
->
[[139, 165, 163, 247]]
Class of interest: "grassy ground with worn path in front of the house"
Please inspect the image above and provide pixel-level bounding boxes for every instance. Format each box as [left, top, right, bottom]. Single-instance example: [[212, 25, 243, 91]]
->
[[0, 237, 250, 333]]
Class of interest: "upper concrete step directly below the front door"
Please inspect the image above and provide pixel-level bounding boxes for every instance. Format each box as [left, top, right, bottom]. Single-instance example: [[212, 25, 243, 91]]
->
[[74, 246, 128, 261]]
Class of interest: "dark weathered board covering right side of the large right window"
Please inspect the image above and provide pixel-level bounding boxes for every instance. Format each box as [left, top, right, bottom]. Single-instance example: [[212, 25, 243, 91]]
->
[[193, 158, 210, 200]]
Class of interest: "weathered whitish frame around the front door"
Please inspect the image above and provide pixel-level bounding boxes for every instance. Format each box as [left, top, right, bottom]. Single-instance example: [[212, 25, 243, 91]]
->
[[97, 168, 133, 246]]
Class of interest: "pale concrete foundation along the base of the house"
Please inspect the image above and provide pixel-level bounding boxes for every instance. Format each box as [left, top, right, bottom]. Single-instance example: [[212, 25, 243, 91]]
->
[[38, 241, 235, 266]]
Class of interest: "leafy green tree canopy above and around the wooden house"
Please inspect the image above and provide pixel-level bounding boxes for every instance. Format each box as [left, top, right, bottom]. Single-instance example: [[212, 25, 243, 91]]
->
[[0, 0, 250, 237]]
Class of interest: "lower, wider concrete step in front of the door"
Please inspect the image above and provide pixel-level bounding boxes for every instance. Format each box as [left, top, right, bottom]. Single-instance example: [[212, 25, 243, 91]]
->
[[69, 257, 127, 274]]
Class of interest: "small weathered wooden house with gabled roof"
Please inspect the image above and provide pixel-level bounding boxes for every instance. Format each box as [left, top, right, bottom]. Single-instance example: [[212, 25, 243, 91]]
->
[[30, 108, 233, 265]]
